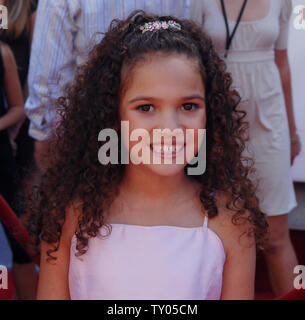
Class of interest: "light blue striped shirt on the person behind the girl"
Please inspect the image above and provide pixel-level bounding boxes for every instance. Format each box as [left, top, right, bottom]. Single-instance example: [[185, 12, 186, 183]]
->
[[25, 0, 191, 141]]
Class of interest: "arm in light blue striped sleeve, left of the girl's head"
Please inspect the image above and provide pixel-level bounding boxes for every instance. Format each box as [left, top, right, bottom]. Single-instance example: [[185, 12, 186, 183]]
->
[[25, 0, 75, 141]]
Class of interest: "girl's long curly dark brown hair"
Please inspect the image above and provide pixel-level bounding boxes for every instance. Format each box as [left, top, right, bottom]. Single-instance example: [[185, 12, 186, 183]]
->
[[28, 11, 267, 258]]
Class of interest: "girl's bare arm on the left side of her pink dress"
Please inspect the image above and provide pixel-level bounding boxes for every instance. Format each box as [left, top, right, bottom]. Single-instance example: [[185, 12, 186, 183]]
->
[[37, 202, 78, 300]]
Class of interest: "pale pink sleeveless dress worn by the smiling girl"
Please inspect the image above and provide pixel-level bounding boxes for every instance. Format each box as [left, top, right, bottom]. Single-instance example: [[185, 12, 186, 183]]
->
[[69, 217, 226, 300]]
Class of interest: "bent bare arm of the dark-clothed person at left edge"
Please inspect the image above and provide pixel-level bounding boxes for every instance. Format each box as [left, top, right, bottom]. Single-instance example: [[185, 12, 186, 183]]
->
[[0, 44, 25, 131]]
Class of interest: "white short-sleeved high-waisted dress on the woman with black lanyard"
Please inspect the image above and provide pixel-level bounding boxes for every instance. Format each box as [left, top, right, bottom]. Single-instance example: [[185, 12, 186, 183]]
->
[[191, 0, 297, 216]]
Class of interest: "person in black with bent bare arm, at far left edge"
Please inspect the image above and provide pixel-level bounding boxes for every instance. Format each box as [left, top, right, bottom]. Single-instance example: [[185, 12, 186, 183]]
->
[[0, 42, 34, 299]]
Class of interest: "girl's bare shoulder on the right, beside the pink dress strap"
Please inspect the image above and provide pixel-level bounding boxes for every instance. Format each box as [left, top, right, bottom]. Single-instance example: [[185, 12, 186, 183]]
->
[[209, 192, 255, 255]]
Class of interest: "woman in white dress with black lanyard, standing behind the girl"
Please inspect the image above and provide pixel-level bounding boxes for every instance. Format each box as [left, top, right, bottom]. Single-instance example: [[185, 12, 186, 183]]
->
[[191, 0, 301, 296]]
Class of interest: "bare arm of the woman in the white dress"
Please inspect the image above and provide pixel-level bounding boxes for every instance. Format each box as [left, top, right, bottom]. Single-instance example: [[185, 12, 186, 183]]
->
[[275, 50, 301, 164]]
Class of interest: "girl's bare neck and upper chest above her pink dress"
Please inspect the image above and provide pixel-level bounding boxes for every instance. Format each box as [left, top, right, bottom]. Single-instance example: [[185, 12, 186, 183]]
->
[[105, 166, 202, 226]]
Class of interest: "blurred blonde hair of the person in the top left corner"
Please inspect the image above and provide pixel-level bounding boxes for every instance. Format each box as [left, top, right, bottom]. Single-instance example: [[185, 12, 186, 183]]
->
[[5, 0, 31, 38]]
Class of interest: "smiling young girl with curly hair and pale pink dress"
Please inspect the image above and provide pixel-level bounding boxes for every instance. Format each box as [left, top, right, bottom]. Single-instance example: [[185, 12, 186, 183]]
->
[[29, 12, 266, 300]]
